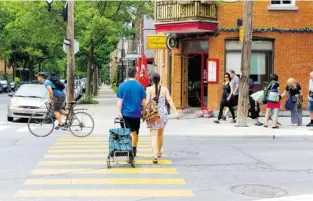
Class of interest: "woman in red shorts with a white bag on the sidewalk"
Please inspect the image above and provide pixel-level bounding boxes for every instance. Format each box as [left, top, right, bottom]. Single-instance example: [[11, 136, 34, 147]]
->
[[264, 74, 281, 129]]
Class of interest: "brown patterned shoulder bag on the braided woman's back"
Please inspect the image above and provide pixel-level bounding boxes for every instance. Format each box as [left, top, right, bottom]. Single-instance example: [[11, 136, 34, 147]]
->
[[143, 86, 161, 127]]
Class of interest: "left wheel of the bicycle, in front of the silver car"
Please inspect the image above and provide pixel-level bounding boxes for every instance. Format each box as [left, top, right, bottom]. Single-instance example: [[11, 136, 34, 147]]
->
[[28, 112, 54, 137]]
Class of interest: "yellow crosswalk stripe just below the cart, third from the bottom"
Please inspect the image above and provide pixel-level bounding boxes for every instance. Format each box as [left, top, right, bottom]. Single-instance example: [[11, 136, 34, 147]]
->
[[32, 168, 179, 175]]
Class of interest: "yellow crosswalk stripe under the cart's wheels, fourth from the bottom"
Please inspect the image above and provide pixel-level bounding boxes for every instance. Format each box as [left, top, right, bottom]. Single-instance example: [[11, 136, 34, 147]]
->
[[38, 160, 173, 166]]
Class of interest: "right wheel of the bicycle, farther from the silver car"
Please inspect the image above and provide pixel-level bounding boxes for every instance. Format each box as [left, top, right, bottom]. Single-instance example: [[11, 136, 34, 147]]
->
[[69, 112, 95, 137]]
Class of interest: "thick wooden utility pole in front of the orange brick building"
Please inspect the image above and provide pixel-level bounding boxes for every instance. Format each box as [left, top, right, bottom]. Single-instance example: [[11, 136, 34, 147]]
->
[[237, 1, 253, 127]]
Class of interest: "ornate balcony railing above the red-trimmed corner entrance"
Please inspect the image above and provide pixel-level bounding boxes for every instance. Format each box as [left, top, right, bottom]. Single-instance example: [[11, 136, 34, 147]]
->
[[156, 0, 218, 23]]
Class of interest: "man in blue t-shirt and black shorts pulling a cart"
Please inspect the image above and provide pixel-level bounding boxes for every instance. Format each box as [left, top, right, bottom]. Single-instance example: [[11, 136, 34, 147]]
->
[[117, 68, 146, 156]]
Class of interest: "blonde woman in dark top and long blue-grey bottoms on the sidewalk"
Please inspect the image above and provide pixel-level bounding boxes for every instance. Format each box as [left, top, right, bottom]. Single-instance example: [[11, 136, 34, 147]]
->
[[281, 78, 302, 126]]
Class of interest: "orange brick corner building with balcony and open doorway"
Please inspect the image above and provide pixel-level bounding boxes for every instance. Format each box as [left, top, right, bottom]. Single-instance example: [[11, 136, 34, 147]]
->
[[155, 0, 313, 110]]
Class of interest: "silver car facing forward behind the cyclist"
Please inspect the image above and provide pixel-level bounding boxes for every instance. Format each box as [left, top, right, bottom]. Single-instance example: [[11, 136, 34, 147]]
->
[[8, 84, 49, 121]]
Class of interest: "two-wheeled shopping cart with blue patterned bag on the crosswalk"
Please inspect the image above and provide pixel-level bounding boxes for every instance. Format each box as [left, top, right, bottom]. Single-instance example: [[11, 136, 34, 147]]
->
[[107, 118, 135, 168]]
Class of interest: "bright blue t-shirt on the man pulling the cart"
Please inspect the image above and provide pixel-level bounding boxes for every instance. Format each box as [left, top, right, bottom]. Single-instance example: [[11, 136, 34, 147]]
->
[[117, 80, 146, 118]]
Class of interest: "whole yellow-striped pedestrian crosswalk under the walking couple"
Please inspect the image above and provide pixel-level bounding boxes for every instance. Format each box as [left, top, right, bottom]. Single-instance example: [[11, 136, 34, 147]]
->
[[14, 136, 194, 198]]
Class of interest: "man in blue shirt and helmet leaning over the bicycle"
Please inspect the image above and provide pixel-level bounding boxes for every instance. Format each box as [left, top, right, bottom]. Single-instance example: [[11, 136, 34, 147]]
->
[[37, 72, 67, 130]]
